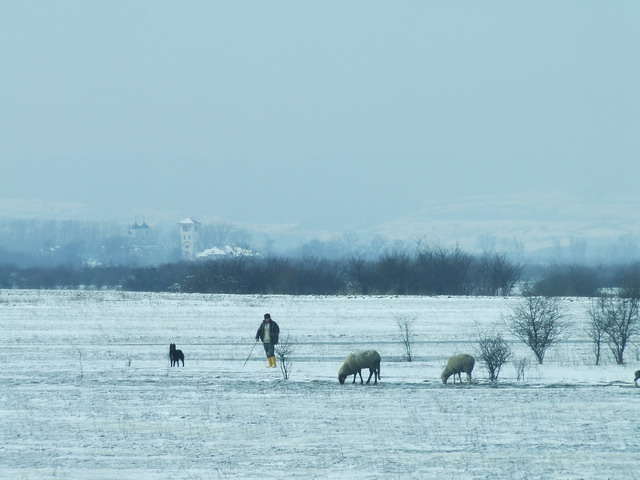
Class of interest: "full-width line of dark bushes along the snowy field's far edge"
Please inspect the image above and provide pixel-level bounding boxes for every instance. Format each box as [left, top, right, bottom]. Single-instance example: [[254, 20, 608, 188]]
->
[[0, 248, 640, 296]]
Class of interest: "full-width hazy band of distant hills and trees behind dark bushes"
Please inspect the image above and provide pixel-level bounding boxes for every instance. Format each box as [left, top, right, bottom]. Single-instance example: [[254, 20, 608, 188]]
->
[[0, 194, 640, 264]]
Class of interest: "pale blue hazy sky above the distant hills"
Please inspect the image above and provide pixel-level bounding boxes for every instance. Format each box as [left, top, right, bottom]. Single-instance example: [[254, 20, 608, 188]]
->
[[0, 0, 640, 234]]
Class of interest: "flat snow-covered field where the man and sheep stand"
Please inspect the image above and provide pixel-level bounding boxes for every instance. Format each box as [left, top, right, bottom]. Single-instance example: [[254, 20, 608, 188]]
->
[[0, 290, 640, 480]]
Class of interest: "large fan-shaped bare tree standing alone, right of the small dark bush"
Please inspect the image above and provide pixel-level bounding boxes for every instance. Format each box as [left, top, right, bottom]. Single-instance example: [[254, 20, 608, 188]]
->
[[507, 294, 569, 364]]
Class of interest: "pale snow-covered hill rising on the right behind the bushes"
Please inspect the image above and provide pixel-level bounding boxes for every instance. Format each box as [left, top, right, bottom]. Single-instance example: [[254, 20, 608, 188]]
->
[[362, 194, 640, 260]]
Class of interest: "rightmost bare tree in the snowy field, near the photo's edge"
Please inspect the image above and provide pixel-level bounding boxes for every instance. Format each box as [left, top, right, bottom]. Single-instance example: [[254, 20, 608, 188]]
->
[[589, 296, 640, 365]]
